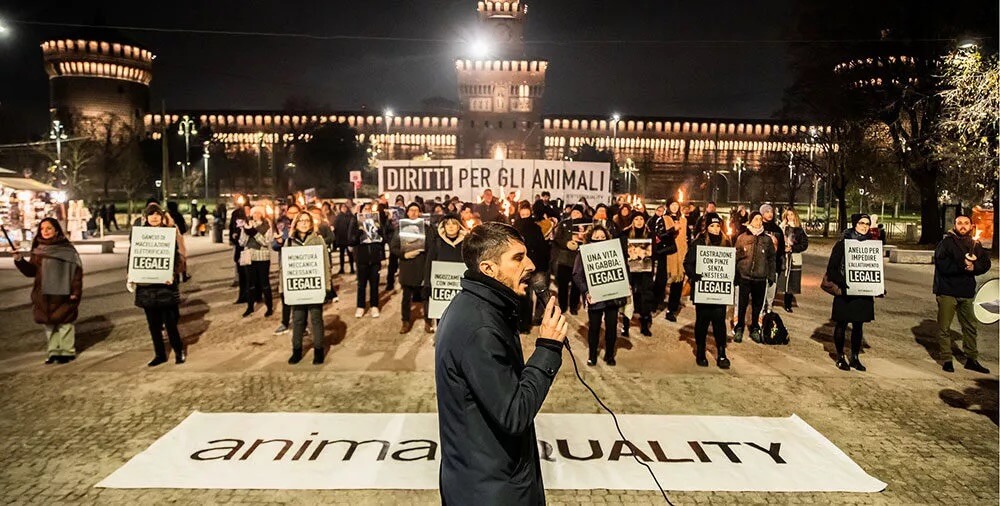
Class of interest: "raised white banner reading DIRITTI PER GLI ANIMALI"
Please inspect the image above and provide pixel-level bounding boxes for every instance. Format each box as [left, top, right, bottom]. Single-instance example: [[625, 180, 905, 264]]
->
[[378, 159, 611, 205]]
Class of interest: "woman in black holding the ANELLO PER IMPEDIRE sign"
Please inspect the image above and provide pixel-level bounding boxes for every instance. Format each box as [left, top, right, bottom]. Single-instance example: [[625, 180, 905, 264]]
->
[[826, 214, 875, 371]]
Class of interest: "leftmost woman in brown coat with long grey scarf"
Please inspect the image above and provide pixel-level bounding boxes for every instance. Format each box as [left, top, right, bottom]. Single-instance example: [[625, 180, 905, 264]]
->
[[14, 218, 83, 364]]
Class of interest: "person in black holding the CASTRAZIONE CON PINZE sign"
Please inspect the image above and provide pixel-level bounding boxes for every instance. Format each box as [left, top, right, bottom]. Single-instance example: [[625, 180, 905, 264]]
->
[[684, 213, 733, 369]]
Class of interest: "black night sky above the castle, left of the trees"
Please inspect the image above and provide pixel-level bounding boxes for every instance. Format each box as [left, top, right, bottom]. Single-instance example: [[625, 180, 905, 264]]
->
[[0, 0, 794, 135]]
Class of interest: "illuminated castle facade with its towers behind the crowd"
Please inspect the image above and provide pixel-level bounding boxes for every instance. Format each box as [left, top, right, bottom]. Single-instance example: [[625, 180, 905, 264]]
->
[[42, 1, 818, 201]]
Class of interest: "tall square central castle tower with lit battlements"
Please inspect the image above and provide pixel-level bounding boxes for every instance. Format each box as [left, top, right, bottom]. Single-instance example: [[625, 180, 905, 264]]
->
[[455, 1, 548, 158]]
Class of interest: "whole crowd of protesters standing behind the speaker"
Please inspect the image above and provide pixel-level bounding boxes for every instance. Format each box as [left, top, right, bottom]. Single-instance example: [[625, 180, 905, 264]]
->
[[7, 189, 990, 372]]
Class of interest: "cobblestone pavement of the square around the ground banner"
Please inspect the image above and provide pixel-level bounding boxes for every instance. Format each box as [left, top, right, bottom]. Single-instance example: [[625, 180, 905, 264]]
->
[[0, 244, 1000, 505]]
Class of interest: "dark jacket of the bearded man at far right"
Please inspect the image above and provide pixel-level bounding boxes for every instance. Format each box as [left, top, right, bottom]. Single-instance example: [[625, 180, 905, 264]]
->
[[934, 230, 991, 299]]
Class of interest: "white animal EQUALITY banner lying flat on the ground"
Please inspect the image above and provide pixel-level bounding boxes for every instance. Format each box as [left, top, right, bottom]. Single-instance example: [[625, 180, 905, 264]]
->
[[97, 412, 886, 492]]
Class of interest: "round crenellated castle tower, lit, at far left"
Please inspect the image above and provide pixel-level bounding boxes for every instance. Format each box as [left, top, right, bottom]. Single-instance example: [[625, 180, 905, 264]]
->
[[42, 31, 156, 134]]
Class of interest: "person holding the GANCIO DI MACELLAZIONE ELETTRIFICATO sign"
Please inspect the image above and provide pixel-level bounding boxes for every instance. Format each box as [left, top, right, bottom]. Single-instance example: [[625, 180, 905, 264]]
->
[[127, 204, 187, 367]]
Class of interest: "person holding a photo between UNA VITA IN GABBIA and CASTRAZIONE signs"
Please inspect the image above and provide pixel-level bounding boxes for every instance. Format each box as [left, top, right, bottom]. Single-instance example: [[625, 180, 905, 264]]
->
[[621, 212, 660, 337]]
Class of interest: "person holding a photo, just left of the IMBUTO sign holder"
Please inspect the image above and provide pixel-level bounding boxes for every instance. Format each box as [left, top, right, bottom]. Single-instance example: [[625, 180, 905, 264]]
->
[[389, 202, 431, 334]]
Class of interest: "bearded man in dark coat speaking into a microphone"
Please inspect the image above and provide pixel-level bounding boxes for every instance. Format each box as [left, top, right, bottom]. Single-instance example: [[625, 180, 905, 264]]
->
[[434, 223, 568, 506]]
